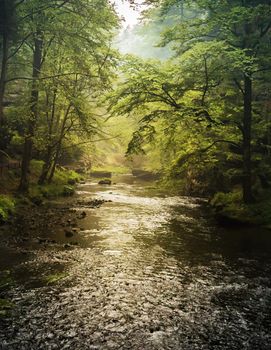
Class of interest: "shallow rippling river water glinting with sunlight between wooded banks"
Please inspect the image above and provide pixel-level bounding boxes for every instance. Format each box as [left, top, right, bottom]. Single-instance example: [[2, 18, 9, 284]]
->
[[0, 176, 271, 350]]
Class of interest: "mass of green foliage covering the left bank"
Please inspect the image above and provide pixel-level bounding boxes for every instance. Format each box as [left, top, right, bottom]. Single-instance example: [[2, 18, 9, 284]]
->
[[0, 0, 118, 190]]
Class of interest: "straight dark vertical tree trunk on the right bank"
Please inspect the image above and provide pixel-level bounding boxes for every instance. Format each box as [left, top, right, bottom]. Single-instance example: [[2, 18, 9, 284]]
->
[[243, 75, 253, 203]]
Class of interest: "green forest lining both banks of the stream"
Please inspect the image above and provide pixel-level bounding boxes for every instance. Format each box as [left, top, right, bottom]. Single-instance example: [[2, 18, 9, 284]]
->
[[0, 0, 271, 223]]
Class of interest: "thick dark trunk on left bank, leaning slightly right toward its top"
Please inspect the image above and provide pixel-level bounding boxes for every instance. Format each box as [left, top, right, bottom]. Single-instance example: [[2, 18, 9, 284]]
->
[[19, 31, 43, 192]]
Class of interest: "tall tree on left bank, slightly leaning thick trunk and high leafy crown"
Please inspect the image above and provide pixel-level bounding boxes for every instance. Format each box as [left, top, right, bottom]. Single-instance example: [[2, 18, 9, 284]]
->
[[11, 0, 117, 192]]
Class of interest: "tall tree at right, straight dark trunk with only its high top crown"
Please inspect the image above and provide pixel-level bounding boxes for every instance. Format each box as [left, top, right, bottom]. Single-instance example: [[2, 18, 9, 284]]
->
[[159, 0, 271, 203]]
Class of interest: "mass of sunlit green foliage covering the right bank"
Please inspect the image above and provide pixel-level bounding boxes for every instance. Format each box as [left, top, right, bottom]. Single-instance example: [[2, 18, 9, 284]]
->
[[109, 0, 271, 202]]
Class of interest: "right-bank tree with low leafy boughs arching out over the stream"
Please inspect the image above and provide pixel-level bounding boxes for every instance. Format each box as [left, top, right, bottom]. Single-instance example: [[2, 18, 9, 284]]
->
[[111, 0, 271, 203]]
